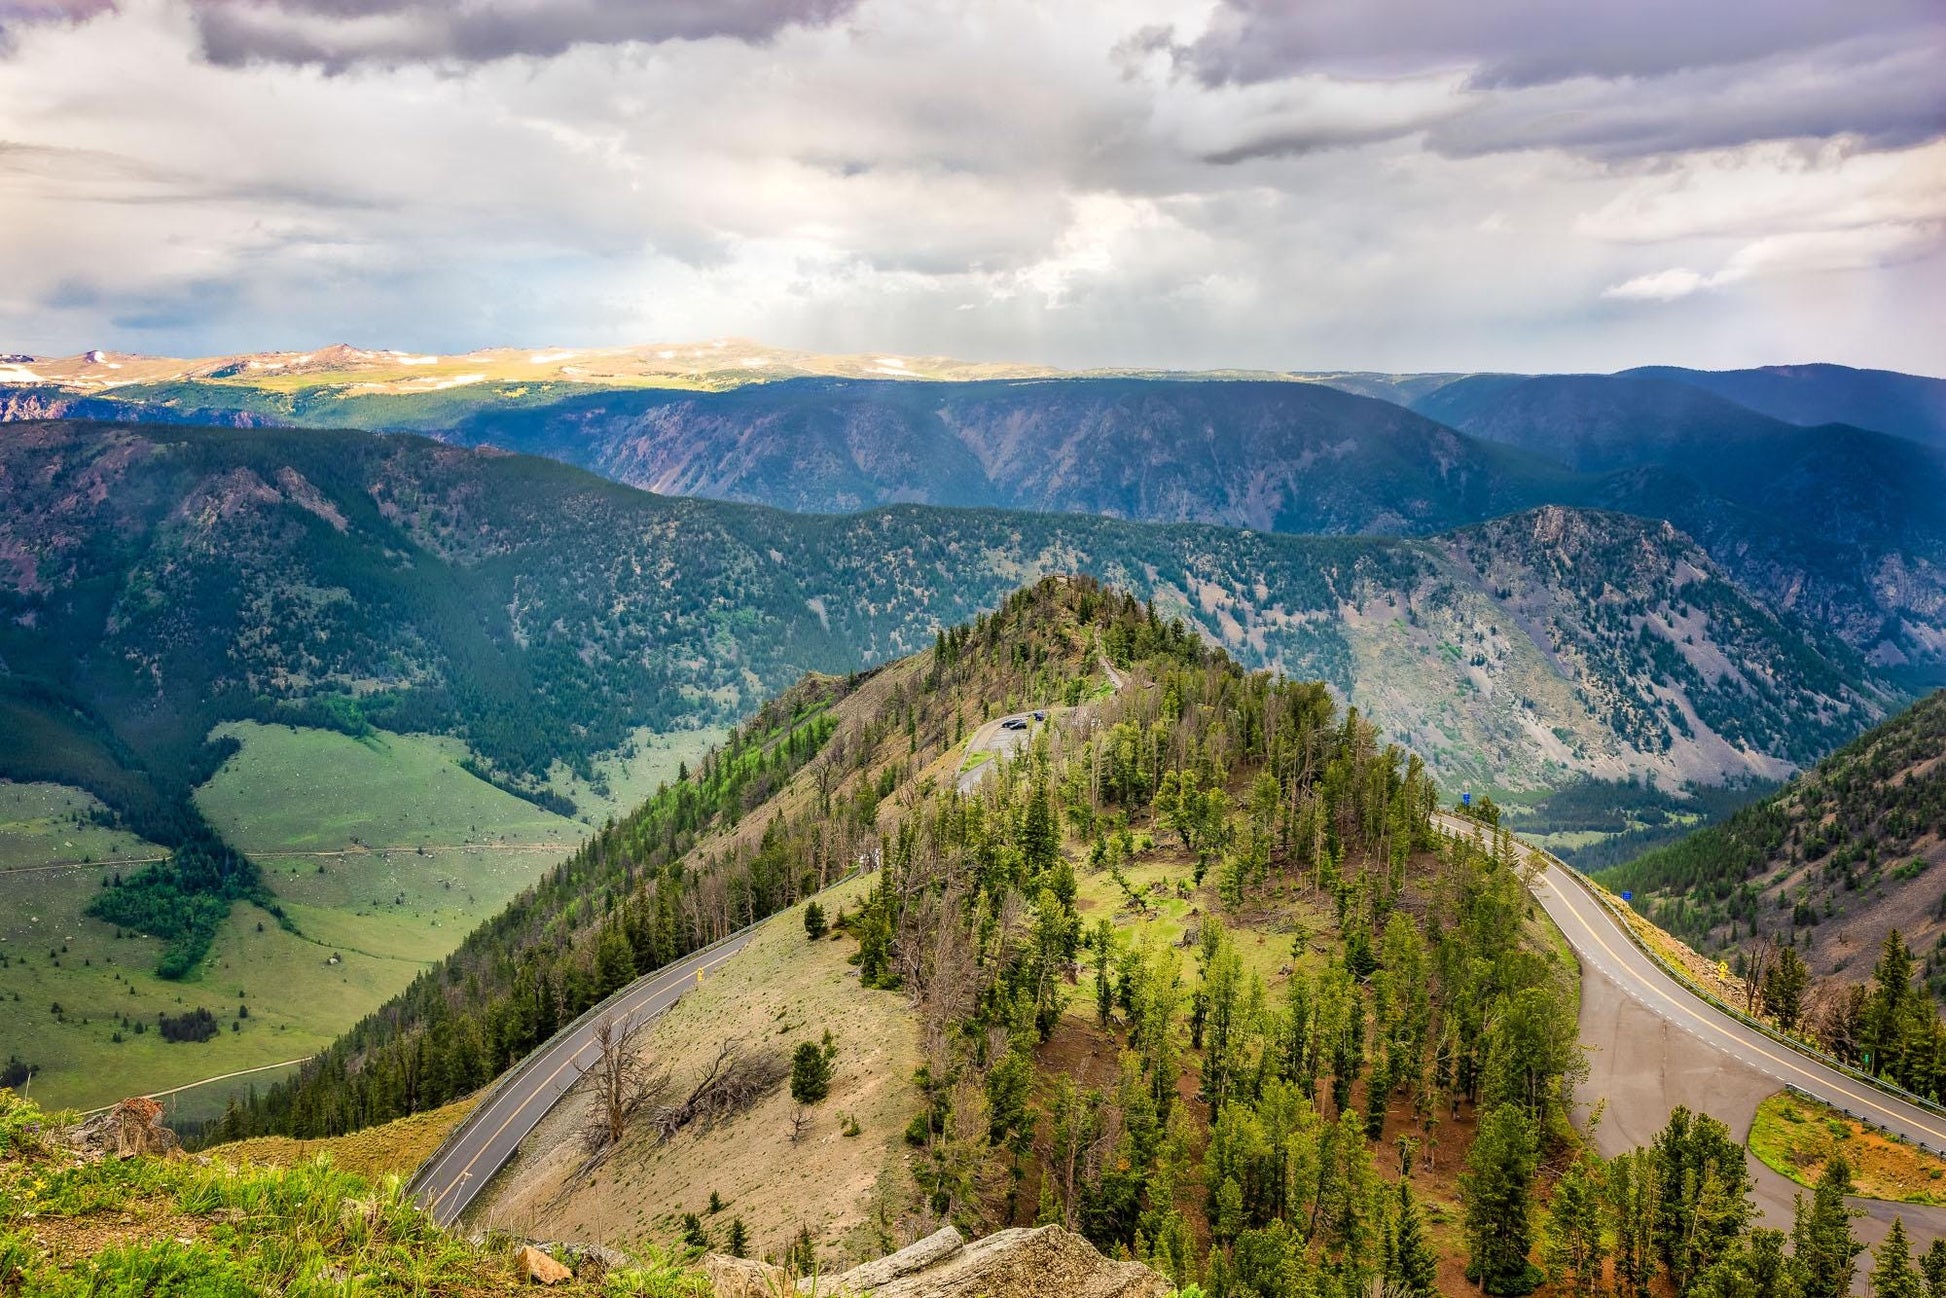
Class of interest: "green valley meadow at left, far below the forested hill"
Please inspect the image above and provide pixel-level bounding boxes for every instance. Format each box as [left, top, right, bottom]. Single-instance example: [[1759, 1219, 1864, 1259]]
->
[[0, 722, 708, 1121]]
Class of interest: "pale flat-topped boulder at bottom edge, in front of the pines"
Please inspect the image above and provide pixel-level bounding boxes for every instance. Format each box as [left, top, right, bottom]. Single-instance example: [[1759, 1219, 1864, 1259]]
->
[[817, 1226, 1175, 1298]]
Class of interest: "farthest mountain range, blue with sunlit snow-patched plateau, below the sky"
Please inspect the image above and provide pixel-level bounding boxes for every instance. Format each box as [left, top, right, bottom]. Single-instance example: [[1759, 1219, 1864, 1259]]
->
[[0, 356, 1946, 689]]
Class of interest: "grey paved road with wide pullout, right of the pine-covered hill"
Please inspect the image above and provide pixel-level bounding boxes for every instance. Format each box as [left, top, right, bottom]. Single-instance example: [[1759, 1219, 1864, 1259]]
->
[[1440, 817, 1946, 1292]]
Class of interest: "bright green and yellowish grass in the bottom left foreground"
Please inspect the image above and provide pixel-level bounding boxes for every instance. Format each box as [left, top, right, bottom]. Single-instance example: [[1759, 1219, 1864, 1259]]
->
[[0, 1090, 710, 1298]]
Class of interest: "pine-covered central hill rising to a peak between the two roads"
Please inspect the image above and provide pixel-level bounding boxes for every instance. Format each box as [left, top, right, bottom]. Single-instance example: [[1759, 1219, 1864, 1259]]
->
[[209, 580, 1578, 1292]]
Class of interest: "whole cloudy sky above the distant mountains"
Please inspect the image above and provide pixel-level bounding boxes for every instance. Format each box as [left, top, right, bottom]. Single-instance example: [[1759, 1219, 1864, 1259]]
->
[[0, 0, 1946, 374]]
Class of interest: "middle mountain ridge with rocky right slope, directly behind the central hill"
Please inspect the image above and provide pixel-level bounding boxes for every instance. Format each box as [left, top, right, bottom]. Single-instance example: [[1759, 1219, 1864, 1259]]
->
[[0, 422, 1888, 864]]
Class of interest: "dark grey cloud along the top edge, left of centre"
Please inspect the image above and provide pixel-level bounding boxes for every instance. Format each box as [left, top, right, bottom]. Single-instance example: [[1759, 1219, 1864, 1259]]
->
[[195, 0, 856, 68]]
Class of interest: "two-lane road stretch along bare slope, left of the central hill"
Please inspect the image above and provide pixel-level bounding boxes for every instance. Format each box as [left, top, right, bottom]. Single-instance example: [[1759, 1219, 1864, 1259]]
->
[[413, 930, 755, 1226]]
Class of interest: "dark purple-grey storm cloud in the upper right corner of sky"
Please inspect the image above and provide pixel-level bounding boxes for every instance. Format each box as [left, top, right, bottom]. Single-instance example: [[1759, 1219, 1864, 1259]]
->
[[1167, 0, 1946, 162]]
